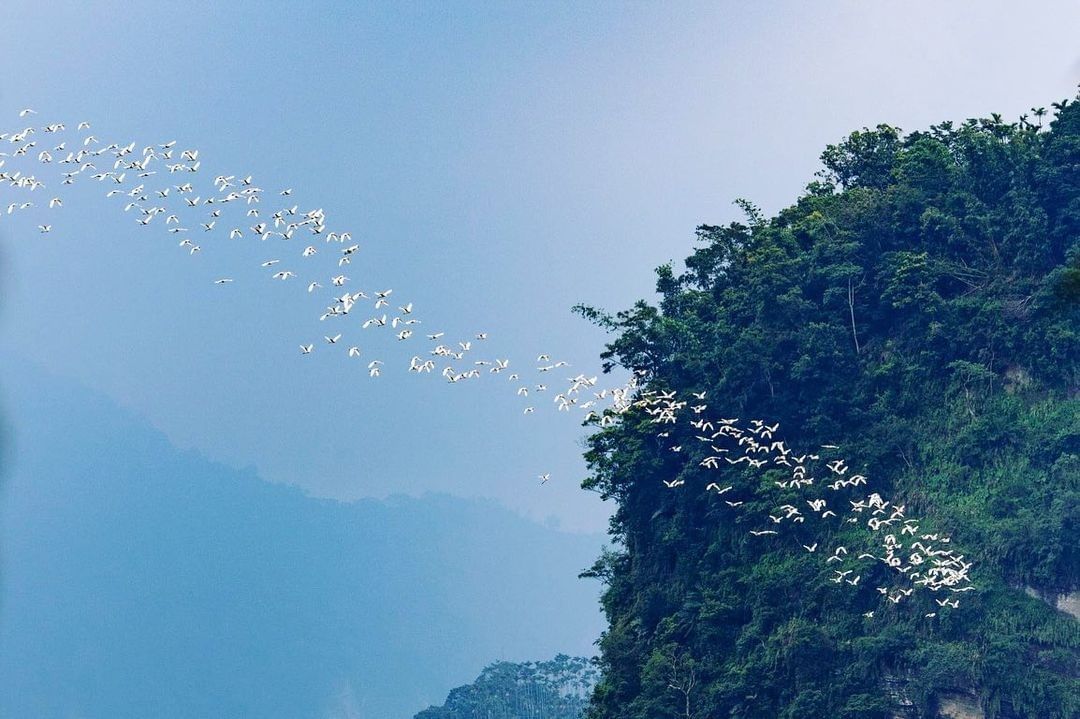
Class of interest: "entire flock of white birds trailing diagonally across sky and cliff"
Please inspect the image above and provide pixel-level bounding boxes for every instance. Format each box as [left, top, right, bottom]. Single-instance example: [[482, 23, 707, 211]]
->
[[0, 109, 974, 619]]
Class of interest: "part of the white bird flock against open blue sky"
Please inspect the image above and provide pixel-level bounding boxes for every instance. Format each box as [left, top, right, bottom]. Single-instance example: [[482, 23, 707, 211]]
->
[[0, 108, 591, 392]]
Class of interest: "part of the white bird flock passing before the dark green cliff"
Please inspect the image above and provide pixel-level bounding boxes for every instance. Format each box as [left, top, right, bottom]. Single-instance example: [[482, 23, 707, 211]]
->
[[632, 390, 975, 618]]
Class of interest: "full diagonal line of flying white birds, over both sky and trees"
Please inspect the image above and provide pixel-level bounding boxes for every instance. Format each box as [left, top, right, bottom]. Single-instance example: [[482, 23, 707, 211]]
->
[[0, 108, 974, 618]]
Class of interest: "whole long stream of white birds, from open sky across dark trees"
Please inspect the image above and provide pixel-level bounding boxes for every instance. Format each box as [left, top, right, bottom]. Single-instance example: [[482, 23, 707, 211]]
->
[[0, 108, 974, 616]]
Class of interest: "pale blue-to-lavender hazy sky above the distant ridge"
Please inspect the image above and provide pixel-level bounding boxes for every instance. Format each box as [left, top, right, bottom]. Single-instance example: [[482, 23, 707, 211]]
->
[[0, 0, 1080, 531]]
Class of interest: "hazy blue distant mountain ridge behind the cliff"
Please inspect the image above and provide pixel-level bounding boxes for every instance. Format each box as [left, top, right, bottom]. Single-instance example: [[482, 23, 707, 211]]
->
[[0, 358, 602, 719]]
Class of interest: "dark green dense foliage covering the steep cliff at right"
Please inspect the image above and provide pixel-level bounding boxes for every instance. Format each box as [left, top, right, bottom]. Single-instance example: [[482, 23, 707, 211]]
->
[[580, 96, 1080, 719]]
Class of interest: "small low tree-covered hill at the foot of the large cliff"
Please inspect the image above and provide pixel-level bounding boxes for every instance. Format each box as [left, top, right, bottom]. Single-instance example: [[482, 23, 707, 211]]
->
[[416, 654, 596, 719]]
